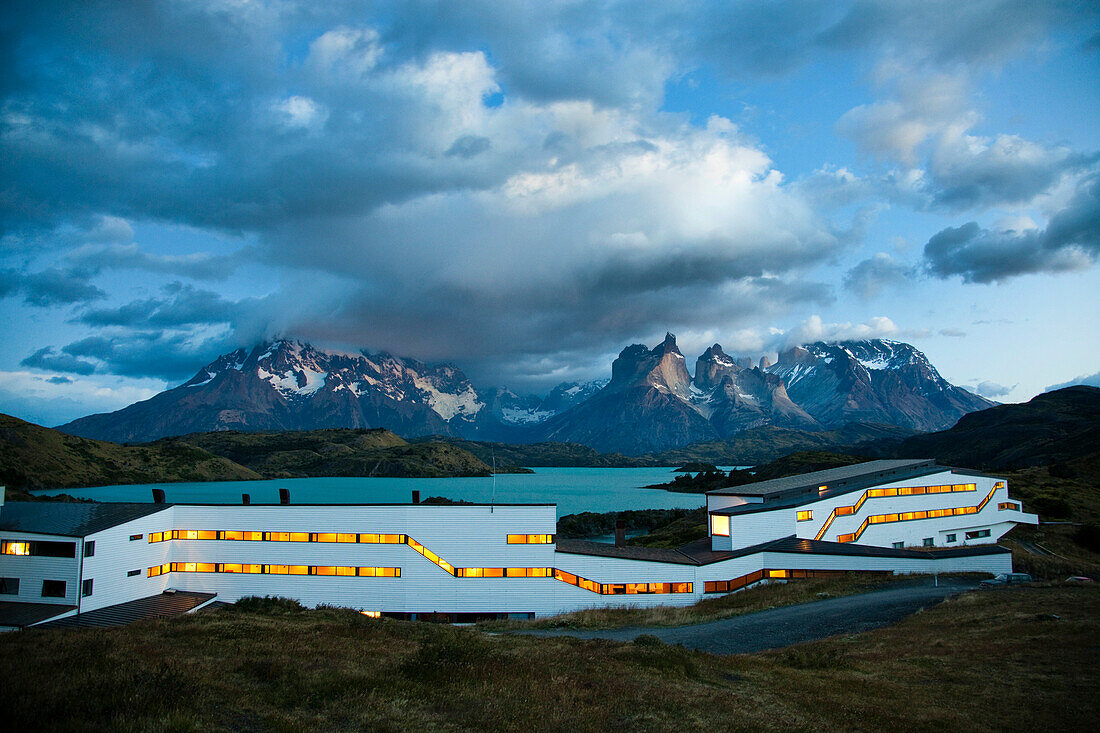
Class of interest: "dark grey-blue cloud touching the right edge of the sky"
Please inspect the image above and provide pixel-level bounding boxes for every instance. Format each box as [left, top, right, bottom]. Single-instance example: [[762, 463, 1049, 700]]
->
[[924, 176, 1100, 283]]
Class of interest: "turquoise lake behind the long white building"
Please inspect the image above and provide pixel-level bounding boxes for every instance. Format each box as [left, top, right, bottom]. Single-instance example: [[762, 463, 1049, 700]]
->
[[41, 468, 705, 517]]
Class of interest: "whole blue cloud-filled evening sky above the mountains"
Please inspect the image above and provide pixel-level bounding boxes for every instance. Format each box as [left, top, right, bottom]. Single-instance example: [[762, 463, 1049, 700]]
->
[[0, 0, 1100, 424]]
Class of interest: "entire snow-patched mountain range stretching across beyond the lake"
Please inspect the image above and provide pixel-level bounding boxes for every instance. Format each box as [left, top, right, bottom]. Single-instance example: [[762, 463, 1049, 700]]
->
[[58, 333, 994, 456]]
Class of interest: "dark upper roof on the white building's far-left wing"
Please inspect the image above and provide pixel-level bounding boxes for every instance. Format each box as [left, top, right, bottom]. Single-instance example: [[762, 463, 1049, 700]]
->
[[0, 502, 171, 537]]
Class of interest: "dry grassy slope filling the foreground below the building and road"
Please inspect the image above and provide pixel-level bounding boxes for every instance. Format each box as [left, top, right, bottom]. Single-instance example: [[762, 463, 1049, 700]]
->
[[0, 587, 1100, 731]]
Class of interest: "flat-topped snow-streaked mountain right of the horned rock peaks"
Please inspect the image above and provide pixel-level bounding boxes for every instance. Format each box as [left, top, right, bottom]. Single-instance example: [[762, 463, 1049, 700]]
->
[[767, 339, 996, 430]]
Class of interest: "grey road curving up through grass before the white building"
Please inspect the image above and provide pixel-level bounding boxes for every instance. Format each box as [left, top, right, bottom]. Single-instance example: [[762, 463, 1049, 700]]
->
[[525, 578, 978, 654]]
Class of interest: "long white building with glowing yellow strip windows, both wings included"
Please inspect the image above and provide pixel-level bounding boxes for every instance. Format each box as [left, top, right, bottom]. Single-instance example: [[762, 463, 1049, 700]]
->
[[0, 461, 1036, 628]]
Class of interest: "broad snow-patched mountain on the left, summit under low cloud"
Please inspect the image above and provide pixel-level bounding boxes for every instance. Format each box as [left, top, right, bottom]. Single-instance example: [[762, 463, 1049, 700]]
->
[[61, 339, 492, 441]]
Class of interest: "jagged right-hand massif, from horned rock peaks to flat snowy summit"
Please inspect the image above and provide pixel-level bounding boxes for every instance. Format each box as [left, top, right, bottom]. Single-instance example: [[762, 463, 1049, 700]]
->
[[536, 333, 993, 453]]
